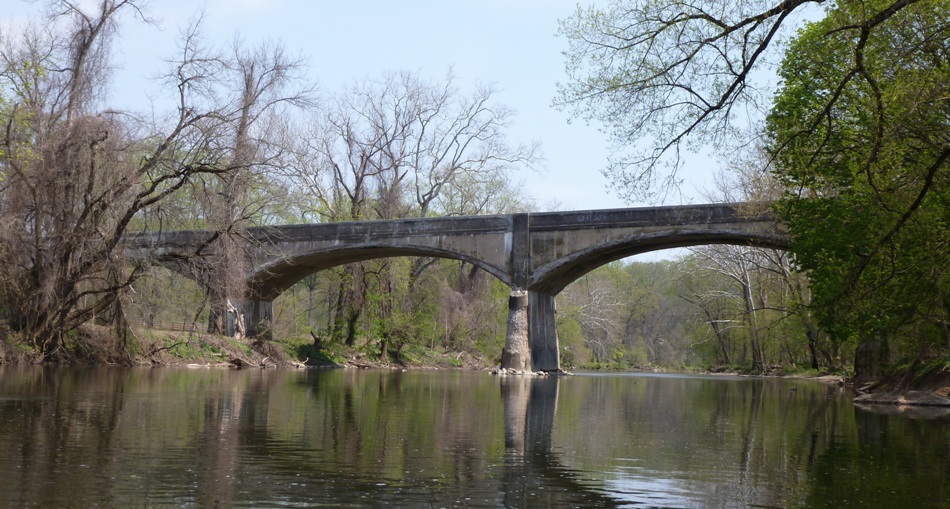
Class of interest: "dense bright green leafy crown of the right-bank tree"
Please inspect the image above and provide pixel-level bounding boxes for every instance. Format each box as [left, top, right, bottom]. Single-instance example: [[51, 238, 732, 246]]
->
[[767, 1, 950, 353]]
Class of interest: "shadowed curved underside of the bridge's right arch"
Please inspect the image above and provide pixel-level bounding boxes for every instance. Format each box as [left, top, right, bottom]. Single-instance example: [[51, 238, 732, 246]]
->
[[528, 228, 789, 295]]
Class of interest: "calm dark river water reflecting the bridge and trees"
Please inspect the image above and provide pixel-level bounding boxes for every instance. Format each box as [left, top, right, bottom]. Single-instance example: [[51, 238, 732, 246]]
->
[[0, 366, 950, 508]]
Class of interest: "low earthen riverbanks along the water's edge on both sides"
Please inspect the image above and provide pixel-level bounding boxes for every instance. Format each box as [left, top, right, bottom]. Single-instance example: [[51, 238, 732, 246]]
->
[[0, 325, 950, 408]]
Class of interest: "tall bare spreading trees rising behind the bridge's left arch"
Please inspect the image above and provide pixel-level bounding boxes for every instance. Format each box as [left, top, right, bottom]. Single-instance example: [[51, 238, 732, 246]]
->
[[287, 72, 539, 345]]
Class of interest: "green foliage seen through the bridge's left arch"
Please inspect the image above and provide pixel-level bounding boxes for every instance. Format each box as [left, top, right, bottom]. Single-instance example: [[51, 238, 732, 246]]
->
[[274, 258, 510, 363]]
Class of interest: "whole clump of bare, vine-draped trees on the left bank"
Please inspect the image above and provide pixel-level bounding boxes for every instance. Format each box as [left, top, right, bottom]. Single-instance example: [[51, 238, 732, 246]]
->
[[0, 0, 320, 360]]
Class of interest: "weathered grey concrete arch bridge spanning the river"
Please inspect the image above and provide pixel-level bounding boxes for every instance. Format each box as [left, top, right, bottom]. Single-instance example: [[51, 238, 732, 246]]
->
[[128, 203, 789, 371]]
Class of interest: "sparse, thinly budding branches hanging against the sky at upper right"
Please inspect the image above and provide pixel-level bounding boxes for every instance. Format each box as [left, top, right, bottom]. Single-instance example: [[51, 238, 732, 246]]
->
[[555, 0, 820, 199]]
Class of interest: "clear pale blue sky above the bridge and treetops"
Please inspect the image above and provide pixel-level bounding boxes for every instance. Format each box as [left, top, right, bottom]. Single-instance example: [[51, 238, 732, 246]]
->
[[0, 0, 712, 210]]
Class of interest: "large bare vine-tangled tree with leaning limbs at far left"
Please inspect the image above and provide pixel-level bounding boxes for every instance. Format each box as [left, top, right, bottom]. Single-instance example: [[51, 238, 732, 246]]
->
[[0, 0, 195, 356]]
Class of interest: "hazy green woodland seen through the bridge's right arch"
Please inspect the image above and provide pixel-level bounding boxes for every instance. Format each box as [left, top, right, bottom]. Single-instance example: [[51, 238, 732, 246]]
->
[[557, 254, 824, 372]]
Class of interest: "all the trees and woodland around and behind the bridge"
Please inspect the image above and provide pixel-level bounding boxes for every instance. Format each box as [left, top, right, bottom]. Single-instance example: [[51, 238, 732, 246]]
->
[[0, 0, 950, 378]]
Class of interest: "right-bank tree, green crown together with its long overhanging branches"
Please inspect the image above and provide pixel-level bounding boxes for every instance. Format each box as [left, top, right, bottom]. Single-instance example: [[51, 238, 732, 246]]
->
[[558, 0, 950, 366]]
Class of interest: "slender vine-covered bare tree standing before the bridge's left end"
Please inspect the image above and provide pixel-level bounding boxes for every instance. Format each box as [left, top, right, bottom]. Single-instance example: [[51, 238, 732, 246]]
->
[[198, 36, 311, 335]]
